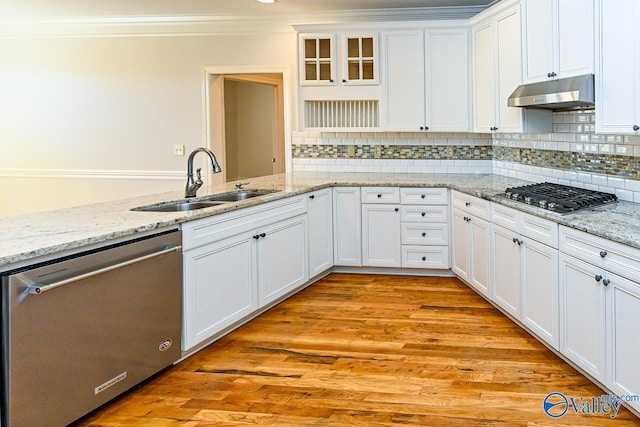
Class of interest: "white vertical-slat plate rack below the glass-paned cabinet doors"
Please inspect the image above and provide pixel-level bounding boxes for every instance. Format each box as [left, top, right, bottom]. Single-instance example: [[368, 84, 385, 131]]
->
[[304, 100, 379, 128]]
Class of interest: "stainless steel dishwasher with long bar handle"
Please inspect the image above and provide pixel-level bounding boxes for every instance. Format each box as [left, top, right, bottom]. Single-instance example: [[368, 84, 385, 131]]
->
[[0, 230, 182, 427]]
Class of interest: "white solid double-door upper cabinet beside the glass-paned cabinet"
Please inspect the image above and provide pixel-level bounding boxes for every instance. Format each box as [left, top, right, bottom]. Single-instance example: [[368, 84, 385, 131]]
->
[[382, 27, 470, 132]]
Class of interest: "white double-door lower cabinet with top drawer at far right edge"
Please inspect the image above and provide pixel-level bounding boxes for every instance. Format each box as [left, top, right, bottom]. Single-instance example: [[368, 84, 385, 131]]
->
[[560, 227, 640, 410]]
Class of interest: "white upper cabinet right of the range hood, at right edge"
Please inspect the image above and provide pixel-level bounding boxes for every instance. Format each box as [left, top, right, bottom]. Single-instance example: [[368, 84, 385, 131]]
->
[[596, 0, 640, 134]]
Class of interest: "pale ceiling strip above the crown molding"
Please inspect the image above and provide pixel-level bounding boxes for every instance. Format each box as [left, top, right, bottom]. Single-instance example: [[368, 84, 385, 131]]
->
[[0, 0, 496, 22]]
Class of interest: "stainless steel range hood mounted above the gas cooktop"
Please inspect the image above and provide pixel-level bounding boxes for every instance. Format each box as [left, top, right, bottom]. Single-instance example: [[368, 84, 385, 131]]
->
[[508, 74, 595, 110]]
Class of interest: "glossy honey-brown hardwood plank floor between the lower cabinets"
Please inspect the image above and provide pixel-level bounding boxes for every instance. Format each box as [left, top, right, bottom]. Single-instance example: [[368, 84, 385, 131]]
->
[[77, 274, 640, 427]]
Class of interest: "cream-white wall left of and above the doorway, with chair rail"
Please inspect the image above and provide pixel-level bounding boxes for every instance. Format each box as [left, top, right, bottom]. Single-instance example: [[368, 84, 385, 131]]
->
[[0, 31, 296, 216]]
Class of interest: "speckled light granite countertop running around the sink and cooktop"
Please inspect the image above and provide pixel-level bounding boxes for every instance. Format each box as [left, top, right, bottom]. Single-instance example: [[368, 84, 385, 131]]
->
[[0, 172, 640, 271]]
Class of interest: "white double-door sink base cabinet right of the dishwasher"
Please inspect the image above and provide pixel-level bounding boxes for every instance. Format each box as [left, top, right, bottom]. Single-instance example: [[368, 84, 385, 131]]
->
[[182, 196, 309, 350]]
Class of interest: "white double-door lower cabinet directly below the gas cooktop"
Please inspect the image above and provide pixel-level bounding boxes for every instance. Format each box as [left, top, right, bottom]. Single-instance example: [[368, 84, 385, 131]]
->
[[491, 204, 559, 349]]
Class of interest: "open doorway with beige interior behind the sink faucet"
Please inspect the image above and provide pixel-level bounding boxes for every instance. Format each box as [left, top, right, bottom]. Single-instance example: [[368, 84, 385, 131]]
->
[[205, 68, 290, 184]]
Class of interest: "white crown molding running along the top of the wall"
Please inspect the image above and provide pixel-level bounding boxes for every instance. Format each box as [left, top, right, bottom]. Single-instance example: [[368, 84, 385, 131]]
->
[[0, 6, 486, 37]]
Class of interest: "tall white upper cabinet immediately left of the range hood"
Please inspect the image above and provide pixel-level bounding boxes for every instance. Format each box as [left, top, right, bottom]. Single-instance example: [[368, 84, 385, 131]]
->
[[471, 1, 551, 133]]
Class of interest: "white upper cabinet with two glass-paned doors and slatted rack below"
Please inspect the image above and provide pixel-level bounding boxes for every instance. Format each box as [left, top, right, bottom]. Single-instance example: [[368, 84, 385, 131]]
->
[[298, 25, 382, 131]]
